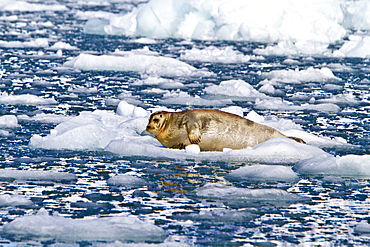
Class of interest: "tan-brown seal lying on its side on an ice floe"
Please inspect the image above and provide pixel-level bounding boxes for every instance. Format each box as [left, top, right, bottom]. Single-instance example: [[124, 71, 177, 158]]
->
[[146, 109, 305, 151]]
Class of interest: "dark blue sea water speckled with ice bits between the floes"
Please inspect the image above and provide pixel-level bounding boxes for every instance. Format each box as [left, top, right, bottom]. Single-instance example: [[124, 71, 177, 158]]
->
[[0, 1, 370, 246]]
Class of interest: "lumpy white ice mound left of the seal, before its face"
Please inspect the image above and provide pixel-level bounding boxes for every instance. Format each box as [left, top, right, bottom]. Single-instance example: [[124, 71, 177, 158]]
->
[[29, 102, 151, 150]]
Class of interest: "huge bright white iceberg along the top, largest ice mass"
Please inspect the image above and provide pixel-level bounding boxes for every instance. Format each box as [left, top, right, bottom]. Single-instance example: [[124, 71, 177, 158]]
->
[[84, 0, 350, 43]]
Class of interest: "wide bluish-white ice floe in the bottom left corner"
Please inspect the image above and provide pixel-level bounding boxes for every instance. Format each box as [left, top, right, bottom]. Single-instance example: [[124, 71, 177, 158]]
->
[[2, 209, 166, 242]]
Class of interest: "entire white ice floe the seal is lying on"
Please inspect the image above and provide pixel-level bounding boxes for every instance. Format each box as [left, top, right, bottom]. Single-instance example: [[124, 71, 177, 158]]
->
[[30, 101, 333, 164]]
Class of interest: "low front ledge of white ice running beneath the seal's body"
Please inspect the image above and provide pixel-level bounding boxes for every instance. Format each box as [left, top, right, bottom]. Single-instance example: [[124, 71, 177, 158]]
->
[[105, 138, 325, 165]]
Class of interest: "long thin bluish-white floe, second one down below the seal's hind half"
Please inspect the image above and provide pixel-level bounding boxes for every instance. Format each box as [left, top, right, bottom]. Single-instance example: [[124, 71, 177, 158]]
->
[[195, 183, 307, 201]]
